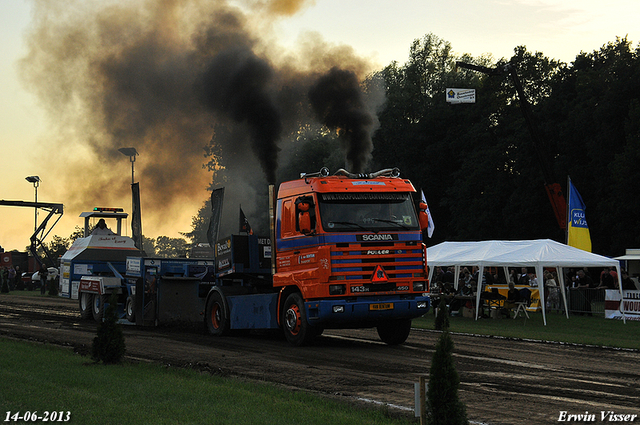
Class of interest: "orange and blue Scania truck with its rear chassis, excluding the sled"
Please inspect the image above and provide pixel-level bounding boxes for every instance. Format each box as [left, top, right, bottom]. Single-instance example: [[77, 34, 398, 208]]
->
[[204, 168, 430, 346]]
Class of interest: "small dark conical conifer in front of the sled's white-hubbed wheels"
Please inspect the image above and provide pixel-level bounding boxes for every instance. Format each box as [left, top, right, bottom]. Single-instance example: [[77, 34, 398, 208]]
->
[[91, 293, 126, 364]]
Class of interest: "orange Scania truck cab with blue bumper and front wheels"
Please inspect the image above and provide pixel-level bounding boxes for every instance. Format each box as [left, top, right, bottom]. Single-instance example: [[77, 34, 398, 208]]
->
[[273, 169, 429, 344]]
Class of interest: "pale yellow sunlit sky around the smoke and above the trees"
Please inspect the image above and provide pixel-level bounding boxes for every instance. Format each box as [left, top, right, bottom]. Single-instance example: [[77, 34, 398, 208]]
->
[[0, 0, 640, 250]]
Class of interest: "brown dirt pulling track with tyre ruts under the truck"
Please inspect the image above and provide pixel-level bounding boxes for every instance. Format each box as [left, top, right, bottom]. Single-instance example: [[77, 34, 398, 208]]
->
[[0, 295, 640, 425]]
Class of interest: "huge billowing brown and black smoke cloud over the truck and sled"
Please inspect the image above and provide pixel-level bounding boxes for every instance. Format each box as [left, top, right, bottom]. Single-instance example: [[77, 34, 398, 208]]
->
[[20, 0, 382, 237]]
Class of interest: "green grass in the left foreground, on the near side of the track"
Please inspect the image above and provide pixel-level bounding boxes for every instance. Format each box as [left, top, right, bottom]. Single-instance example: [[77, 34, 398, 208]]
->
[[0, 337, 415, 425]]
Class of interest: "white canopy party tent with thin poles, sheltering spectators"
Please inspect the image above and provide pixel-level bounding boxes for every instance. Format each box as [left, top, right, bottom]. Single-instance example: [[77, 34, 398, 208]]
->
[[427, 239, 624, 326]]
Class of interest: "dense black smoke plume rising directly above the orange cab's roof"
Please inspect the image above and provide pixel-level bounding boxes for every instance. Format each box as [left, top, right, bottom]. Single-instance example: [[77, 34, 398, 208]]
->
[[309, 67, 374, 173]]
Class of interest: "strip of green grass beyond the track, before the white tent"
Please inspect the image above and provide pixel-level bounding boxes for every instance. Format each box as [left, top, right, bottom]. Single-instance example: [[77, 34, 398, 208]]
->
[[413, 312, 640, 349]]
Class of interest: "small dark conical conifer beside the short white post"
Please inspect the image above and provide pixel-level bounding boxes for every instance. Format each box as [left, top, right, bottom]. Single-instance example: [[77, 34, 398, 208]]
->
[[425, 331, 469, 425]]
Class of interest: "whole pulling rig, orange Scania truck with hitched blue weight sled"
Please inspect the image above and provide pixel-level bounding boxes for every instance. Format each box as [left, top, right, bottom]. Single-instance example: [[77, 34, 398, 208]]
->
[[62, 168, 430, 346]]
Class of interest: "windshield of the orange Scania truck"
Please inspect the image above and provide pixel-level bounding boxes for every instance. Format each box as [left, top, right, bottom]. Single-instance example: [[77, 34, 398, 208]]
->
[[318, 193, 419, 232]]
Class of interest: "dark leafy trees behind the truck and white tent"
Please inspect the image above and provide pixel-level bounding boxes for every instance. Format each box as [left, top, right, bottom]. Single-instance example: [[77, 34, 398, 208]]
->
[[36, 34, 640, 256]]
